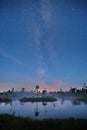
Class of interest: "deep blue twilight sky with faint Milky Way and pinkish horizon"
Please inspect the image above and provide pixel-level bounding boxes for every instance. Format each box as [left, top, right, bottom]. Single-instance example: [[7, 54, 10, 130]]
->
[[0, 0, 87, 91]]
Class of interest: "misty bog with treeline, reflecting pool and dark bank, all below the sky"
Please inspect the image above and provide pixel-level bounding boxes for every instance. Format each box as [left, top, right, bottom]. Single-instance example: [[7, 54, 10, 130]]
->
[[0, 84, 87, 130]]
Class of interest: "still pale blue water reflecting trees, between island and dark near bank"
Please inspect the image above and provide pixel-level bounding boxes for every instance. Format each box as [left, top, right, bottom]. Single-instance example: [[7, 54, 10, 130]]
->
[[0, 99, 87, 119]]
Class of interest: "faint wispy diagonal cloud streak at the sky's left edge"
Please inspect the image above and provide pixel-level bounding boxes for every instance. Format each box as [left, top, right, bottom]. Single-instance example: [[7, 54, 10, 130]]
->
[[0, 48, 22, 64]]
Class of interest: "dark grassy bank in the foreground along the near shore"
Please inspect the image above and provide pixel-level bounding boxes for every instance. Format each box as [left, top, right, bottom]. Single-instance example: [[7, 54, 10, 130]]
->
[[0, 114, 87, 130]]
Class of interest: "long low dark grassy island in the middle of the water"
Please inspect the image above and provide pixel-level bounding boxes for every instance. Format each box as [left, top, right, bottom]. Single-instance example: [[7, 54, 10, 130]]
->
[[20, 97, 57, 102]]
